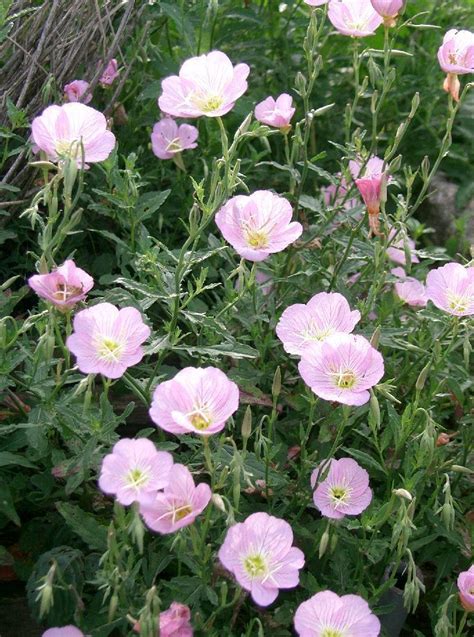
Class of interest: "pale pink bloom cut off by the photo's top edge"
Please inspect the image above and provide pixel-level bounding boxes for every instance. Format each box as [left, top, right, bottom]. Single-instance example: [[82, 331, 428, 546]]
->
[[328, 0, 383, 38]]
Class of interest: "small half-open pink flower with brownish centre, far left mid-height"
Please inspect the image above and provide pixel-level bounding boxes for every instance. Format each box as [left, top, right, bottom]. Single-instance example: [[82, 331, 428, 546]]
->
[[28, 259, 94, 310]]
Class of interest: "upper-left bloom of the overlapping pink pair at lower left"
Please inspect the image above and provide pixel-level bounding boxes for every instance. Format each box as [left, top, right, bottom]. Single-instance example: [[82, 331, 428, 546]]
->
[[99, 438, 173, 505]]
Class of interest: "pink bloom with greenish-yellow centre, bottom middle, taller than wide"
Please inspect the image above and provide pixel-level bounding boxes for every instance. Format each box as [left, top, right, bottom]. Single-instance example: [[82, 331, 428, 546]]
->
[[219, 513, 304, 606]]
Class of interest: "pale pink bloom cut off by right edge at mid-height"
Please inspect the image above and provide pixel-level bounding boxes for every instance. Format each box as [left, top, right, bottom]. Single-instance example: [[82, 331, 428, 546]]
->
[[426, 263, 474, 316]]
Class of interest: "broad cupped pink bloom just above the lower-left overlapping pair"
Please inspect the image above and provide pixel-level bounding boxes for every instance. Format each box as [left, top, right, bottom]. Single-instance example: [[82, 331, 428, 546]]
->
[[150, 367, 239, 436]]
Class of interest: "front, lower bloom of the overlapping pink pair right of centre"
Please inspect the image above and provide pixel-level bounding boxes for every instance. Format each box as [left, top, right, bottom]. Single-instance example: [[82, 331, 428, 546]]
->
[[298, 333, 384, 405]]
